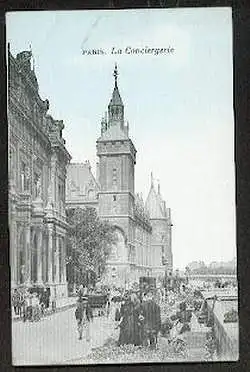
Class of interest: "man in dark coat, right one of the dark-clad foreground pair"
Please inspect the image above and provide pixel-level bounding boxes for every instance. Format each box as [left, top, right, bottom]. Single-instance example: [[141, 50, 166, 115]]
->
[[142, 291, 161, 347]]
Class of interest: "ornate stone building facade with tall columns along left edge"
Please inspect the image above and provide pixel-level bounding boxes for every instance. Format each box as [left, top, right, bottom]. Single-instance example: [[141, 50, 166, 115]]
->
[[8, 46, 71, 297]]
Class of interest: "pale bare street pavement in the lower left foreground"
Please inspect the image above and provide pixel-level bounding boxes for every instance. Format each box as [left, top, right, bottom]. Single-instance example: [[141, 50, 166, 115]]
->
[[12, 308, 117, 366]]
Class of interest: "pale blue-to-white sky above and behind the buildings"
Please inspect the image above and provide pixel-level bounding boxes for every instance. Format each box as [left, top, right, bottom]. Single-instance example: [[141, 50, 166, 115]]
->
[[6, 8, 236, 268]]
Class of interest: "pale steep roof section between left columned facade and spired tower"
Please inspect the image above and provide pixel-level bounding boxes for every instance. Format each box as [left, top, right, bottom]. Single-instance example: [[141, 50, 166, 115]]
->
[[66, 161, 99, 201]]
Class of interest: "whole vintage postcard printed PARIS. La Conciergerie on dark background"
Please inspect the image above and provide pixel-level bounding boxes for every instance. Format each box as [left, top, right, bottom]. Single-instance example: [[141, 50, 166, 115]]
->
[[6, 8, 239, 366]]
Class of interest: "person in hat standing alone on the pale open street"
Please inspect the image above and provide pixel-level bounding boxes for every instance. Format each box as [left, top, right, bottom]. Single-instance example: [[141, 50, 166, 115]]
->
[[75, 296, 93, 342]]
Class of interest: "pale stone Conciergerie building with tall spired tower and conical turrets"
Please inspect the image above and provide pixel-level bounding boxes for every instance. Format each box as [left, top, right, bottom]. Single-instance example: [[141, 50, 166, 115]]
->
[[66, 67, 172, 285]]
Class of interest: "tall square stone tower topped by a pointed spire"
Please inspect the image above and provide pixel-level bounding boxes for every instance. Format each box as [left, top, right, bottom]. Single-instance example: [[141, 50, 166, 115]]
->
[[97, 65, 136, 284]]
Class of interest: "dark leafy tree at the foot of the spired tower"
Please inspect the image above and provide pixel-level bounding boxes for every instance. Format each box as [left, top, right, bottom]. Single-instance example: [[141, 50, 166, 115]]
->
[[67, 208, 116, 282]]
